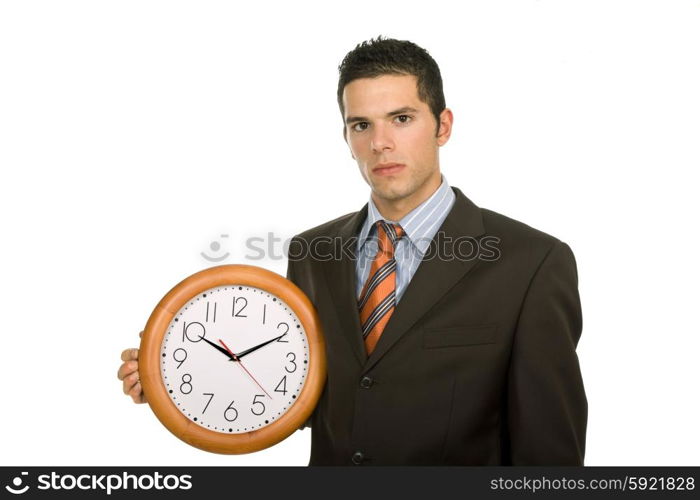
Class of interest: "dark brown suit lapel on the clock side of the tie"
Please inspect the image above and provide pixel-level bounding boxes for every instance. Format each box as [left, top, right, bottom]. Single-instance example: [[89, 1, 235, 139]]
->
[[323, 205, 367, 365]]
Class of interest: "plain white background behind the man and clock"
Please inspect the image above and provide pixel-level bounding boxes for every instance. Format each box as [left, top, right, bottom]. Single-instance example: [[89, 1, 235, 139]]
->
[[0, 0, 700, 465]]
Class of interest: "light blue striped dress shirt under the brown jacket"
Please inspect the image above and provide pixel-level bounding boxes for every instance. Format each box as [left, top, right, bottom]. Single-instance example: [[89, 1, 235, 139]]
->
[[355, 175, 455, 304]]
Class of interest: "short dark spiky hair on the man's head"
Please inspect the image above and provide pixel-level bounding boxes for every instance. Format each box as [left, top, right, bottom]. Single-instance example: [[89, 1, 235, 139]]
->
[[338, 35, 445, 127]]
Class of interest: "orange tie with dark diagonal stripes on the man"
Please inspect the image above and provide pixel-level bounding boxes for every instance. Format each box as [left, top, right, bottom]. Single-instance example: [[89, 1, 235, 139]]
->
[[358, 220, 405, 356]]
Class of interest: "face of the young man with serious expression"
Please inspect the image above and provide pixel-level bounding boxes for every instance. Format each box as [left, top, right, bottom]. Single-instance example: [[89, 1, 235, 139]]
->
[[343, 75, 452, 202]]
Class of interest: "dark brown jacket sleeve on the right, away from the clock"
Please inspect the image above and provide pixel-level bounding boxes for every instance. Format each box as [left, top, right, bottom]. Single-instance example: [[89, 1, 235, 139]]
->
[[507, 241, 588, 465]]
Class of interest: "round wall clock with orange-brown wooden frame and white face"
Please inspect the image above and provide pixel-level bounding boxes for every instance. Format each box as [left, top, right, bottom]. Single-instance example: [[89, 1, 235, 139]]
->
[[139, 265, 326, 454]]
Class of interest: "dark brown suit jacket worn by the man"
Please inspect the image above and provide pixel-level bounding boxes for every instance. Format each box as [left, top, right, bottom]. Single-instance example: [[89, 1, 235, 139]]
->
[[288, 188, 587, 465]]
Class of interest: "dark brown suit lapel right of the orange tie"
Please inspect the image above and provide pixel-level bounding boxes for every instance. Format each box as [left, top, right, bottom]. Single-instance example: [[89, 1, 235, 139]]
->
[[364, 188, 485, 370]]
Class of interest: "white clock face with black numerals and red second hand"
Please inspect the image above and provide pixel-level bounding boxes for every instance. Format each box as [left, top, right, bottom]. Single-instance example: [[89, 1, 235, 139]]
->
[[160, 285, 309, 434]]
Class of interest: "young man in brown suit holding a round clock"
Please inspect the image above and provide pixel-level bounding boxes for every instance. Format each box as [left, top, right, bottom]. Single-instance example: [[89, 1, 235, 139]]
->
[[119, 38, 587, 465]]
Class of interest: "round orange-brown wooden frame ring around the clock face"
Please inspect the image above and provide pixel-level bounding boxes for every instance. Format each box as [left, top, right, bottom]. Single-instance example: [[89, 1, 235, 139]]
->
[[139, 264, 326, 454]]
